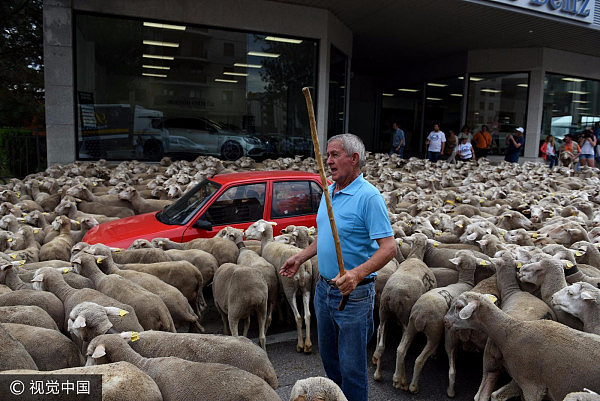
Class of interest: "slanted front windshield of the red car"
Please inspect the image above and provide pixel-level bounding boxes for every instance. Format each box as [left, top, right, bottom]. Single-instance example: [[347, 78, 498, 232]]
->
[[156, 180, 221, 225]]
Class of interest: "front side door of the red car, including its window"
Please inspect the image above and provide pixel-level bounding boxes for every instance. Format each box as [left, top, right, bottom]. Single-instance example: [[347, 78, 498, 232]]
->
[[182, 182, 267, 242]]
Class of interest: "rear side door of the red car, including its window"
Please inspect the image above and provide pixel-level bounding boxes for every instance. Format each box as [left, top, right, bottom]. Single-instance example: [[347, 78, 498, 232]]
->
[[269, 180, 323, 235]]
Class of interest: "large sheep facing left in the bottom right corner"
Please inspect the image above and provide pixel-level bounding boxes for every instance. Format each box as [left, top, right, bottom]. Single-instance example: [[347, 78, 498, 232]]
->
[[445, 292, 600, 401]]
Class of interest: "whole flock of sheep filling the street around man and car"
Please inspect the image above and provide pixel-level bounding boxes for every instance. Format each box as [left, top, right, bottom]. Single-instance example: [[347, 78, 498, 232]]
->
[[0, 154, 600, 401]]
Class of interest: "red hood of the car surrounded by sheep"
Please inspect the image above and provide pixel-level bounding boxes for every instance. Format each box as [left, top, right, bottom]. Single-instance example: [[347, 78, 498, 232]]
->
[[83, 212, 185, 248]]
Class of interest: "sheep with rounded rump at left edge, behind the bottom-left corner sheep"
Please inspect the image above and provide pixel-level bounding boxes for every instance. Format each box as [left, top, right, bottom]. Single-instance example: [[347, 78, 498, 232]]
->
[[2, 323, 84, 370]]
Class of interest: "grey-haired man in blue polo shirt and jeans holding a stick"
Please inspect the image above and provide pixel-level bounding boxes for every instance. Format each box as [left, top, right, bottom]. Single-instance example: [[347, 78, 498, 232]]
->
[[280, 134, 396, 401]]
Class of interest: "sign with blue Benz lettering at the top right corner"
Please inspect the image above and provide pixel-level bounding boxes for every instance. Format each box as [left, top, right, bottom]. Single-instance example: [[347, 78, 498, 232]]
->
[[488, 0, 596, 24]]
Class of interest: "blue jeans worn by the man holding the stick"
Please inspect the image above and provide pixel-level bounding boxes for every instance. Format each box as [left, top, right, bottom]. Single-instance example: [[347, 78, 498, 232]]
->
[[314, 278, 375, 401]]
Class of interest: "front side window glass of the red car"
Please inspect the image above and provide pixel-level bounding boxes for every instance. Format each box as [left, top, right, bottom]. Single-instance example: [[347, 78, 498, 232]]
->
[[203, 183, 266, 226]]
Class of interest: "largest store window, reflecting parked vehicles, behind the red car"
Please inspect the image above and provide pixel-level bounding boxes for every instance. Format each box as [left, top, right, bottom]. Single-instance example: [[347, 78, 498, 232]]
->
[[75, 13, 318, 160]]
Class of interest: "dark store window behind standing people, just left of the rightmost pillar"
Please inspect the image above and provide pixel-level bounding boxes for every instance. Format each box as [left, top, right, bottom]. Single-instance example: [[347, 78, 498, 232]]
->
[[467, 73, 529, 155]]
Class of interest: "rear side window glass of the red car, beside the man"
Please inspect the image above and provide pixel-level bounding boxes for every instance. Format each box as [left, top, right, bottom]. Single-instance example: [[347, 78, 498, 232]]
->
[[271, 181, 322, 218]]
